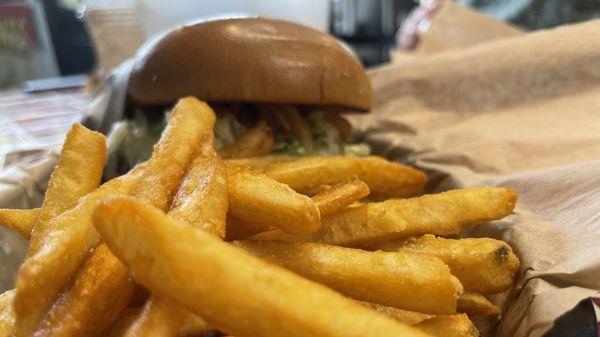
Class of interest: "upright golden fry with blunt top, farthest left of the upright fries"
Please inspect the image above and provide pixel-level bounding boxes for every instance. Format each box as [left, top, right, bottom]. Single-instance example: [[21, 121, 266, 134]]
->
[[27, 124, 107, 256]]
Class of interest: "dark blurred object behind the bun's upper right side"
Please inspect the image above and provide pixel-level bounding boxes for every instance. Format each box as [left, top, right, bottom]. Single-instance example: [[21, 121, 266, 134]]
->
[[330, 0, 417, 66]]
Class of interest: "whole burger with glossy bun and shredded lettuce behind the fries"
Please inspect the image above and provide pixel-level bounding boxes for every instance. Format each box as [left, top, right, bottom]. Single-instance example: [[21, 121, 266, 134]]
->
[[111, 17, 372, 168]]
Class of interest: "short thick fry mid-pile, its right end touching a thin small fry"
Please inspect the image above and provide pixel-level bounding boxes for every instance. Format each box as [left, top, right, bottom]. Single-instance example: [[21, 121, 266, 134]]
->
[[228, 170, 321, 237]]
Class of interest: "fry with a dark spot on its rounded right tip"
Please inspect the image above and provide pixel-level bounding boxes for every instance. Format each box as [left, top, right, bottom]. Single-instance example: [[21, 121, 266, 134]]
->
[[379, 235, 519, 294]]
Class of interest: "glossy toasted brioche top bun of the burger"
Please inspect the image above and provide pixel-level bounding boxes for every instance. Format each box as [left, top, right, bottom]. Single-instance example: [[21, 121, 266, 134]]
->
[[128, 18, 372, 110]]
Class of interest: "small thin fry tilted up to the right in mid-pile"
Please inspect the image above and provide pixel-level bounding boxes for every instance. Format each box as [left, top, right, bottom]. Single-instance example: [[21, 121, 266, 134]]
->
[[312, 177, 369, 217]]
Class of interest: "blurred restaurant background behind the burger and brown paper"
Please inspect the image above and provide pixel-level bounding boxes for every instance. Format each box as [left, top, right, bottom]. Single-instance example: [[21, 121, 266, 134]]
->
[[0, 0, 600, 156]]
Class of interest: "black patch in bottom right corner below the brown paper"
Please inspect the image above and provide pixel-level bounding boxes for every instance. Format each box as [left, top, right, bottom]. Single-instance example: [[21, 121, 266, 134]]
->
[[544, 298, 600, 337]]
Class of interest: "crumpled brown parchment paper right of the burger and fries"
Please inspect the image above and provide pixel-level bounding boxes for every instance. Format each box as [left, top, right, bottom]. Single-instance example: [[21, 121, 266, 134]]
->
[[350, 21, 600, 337]]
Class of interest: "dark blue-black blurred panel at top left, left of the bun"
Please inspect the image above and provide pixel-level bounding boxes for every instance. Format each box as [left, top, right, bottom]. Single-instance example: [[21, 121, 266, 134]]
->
[[42, 0, 96, 75]]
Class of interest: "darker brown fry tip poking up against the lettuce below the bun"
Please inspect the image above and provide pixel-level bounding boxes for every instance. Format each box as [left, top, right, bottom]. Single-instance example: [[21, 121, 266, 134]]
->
[[219, 120, 274, 159]]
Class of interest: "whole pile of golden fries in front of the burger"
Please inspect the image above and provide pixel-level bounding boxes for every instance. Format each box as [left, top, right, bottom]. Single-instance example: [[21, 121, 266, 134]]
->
[[0, 97, 519, 337]]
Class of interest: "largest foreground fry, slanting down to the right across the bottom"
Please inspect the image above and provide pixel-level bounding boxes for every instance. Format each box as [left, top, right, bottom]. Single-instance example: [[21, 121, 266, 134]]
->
[[94, 197, 427, 337]]
